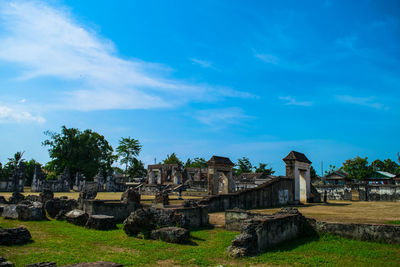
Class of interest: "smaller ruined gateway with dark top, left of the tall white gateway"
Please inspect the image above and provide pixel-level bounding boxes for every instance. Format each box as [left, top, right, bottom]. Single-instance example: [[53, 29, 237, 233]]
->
[[207, 156, 235, 195]]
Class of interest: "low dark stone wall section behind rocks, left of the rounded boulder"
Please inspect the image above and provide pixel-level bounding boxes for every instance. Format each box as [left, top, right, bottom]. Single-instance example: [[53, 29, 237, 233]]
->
[[82, 200, 140, 222]]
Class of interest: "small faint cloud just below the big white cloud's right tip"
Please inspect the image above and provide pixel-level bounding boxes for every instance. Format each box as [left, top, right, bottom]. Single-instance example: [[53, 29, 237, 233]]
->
[[194, 107, 252, 128]]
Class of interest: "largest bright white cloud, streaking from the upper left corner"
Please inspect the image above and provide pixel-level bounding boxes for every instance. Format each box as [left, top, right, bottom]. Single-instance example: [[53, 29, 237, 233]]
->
[[0, 1, 252, 110]]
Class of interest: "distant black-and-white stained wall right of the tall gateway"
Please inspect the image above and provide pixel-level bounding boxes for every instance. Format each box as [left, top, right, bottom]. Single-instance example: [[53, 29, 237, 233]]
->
[[315, 184, 400, 201]]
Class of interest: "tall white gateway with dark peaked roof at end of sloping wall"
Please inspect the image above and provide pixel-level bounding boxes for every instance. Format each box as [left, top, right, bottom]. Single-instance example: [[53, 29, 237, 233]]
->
[[283, 151, 311, 203]]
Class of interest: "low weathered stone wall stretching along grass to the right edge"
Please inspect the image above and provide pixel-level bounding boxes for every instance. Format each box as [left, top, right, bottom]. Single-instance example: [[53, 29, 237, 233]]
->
[[309, 219, 400, 243]]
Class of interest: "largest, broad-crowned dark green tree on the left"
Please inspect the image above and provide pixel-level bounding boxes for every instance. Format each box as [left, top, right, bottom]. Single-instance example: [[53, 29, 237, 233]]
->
[[42, 125, 115, 181]]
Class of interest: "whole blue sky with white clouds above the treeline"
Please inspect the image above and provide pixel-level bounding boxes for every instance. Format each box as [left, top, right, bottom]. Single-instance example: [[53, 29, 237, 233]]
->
[[0, 0, 400, 174]]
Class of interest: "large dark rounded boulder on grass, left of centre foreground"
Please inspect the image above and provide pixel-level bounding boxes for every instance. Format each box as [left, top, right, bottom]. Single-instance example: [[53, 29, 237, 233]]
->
[[124, 207, 188, 236]]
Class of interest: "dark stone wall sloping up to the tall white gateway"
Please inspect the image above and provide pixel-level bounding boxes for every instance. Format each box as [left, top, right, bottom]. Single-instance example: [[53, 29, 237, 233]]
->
[[200, 178, 294, 212]]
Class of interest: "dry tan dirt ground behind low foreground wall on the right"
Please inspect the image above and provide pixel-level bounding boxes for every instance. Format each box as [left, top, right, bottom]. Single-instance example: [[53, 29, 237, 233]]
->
[[210, 201, 400, 226]]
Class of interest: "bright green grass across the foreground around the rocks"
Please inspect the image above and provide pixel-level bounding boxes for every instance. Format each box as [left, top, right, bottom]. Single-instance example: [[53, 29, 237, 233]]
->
[[0, 218, 400, 266]]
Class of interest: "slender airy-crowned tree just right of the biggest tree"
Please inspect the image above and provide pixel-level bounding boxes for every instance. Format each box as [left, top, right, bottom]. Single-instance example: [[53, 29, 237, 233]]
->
[[116, 137, 142, 174]]
